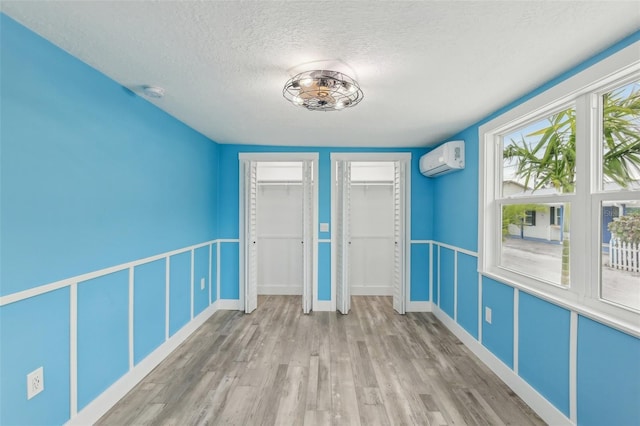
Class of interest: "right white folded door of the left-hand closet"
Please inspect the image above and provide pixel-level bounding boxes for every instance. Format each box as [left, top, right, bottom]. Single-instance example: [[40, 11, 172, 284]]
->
[[302, 160, 314, 314]]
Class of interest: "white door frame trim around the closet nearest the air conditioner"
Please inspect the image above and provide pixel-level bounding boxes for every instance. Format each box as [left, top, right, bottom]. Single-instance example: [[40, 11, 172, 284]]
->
[[331, 152, 411, 311]]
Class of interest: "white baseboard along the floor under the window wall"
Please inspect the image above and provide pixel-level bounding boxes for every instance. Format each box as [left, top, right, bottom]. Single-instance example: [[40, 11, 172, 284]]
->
[[433, 306, 573, 426]]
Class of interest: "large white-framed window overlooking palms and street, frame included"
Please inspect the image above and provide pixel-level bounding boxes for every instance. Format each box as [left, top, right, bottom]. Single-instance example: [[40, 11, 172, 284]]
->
[[479, 43, 640, 334]]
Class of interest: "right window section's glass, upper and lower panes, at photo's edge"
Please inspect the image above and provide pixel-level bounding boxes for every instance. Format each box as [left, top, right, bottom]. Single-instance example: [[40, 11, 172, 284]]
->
[[594, 79, 640, 311]]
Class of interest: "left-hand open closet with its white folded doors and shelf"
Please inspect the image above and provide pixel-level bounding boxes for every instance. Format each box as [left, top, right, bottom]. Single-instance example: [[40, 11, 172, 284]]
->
[[239, 154, 318, 313]]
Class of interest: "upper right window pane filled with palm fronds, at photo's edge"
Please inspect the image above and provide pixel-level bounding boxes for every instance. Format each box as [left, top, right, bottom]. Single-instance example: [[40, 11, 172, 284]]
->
[[602, 81, 640, 191]]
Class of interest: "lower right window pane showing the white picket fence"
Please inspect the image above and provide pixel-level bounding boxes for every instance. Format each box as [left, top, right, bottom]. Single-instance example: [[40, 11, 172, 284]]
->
[[600, 200, 640, 310]]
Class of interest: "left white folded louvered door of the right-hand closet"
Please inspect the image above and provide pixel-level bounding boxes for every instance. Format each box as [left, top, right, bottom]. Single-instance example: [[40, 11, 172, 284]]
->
[[336, 161, 351, 314]]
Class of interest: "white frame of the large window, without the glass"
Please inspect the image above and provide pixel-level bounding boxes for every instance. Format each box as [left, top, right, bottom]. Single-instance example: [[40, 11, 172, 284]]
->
[[478, 42, 640, 336]]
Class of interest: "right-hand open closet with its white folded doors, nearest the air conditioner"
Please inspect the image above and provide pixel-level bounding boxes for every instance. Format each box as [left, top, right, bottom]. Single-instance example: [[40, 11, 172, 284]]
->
[[332, 154, 410, 314]]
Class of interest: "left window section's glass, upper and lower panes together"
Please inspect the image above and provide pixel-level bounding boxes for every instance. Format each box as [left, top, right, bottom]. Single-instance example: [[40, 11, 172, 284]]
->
[[496, 104, 576, 287]]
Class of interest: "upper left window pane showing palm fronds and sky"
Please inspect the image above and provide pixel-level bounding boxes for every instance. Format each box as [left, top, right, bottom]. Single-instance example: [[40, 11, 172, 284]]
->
[[502, 107, 576, 197]]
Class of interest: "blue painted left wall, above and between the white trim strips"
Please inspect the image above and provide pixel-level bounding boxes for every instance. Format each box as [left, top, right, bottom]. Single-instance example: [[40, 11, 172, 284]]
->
[[0, 14, 219, 425]]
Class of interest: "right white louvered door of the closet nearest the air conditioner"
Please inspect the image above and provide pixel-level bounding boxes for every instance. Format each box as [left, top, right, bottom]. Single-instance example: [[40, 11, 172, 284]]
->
[[393, 161, 405, 314]]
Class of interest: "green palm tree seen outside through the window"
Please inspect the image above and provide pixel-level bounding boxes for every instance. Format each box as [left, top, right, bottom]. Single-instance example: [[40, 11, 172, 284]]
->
[[503, 82, 640, 285]]
